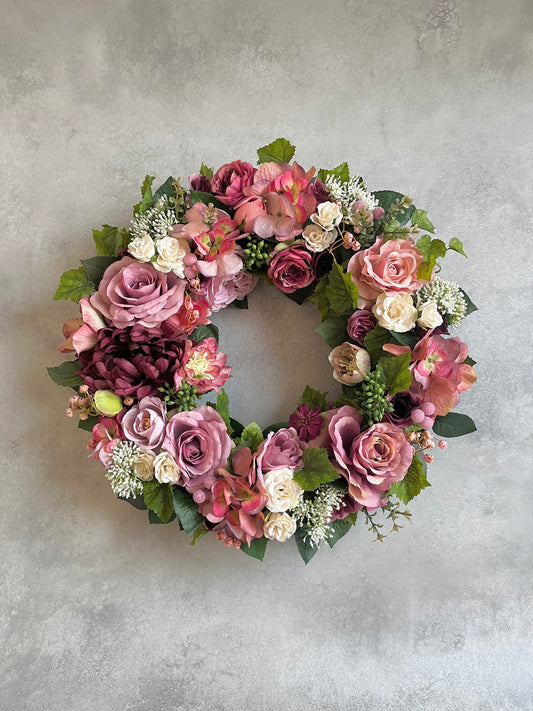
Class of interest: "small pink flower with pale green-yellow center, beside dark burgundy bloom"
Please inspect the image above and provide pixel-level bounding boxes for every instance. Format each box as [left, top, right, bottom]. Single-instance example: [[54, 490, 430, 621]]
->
[[174, 338, 231, 395]]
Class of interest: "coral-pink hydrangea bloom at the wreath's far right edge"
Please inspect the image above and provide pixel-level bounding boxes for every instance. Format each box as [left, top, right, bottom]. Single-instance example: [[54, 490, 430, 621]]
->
[[410, 333, 477, 416]]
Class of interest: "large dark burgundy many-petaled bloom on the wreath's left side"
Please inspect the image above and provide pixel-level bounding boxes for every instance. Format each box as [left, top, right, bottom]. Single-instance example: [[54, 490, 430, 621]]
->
[[79, 324, 185, 399]]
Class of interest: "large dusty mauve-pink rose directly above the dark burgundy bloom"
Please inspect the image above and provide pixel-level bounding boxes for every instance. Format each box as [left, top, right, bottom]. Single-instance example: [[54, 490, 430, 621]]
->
[[90, 257, 185, 328]]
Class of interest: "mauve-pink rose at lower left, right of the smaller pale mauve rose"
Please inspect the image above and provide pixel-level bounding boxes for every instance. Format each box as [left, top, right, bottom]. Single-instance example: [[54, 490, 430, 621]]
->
[[162, 405, 233, 493]]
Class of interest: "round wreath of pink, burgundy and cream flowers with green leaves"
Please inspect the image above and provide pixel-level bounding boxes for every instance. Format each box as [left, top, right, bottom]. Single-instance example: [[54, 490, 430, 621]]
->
[[48, 138, 476, 563]]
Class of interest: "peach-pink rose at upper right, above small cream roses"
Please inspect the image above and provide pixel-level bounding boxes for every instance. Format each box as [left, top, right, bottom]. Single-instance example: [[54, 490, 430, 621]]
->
[[348, 237, 426, 306]]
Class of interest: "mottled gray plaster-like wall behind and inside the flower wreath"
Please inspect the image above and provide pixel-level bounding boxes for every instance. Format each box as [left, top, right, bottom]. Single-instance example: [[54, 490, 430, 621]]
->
[[0, 0, 533, 711]]
